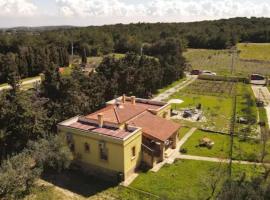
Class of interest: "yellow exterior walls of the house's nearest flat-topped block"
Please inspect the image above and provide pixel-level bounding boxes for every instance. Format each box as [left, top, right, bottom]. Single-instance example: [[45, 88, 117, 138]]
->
[[58, 126, 142, 178]]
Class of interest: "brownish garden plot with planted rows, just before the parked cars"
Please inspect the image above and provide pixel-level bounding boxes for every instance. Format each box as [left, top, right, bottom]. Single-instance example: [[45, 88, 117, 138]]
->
[[183, 80, 235, 97]]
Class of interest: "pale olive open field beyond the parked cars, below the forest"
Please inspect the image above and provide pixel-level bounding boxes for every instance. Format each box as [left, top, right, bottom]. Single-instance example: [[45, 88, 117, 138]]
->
[[184, 49, 270, 77]]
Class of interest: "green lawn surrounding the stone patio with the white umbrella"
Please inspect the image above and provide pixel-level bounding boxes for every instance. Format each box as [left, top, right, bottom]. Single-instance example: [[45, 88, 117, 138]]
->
[[170, 91, 232, 132]]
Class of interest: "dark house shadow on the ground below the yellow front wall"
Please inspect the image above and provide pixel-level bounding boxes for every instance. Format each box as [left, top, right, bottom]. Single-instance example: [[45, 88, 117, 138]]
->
[[41, 169, 117, 197]]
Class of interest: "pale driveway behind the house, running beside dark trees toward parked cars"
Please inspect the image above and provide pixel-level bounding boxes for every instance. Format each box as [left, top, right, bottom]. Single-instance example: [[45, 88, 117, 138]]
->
[[153, 75, 198, 101]]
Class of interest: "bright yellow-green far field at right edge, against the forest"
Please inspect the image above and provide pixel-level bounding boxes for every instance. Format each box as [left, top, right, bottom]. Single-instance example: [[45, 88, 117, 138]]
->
[[237, 43, 270, 62]]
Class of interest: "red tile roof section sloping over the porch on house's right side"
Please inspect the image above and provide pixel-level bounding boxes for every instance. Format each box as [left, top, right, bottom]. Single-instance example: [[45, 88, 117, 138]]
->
[[128, 111, 180, 142]]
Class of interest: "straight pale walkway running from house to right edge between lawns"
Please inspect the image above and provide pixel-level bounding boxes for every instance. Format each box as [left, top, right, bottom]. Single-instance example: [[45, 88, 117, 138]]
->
[[177, 154, 270, 166]]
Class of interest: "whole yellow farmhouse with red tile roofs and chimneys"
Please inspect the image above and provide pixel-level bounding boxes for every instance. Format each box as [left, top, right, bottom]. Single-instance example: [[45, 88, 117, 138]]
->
[[58, 95, 180, 181]]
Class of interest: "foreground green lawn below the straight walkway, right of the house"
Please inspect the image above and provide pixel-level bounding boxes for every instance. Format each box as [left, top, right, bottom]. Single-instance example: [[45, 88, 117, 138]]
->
[[131, 160, 262, 200]]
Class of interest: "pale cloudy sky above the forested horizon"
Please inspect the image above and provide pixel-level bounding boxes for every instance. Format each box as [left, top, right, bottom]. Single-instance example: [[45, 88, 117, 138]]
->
[[0, 0, 270, 27]]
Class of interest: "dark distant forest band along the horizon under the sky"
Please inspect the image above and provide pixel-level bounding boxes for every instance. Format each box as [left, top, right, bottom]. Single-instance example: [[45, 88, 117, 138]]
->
[[0, 17, 270, 55]]
